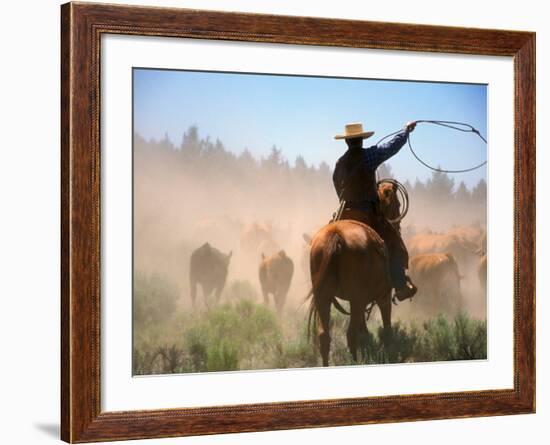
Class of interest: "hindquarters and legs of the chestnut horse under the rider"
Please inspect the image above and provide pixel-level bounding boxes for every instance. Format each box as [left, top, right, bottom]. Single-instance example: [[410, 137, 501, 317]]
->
[[308, 220, 392, 366]]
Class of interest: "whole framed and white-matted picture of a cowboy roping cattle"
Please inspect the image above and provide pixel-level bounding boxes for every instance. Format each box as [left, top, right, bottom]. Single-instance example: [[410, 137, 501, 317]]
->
[[61, 3, 535, 443]]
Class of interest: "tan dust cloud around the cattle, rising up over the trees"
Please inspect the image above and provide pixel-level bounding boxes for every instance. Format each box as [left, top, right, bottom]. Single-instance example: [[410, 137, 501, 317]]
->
[[134, 128, 486, 320]]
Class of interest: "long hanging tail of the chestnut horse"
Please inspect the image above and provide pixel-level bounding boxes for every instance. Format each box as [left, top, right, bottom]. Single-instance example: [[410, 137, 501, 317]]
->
[[307, 231, 349, 338]]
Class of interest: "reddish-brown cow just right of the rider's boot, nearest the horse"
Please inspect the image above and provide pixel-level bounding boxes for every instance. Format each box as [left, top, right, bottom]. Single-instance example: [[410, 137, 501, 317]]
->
[[409, 253, 462, 313]]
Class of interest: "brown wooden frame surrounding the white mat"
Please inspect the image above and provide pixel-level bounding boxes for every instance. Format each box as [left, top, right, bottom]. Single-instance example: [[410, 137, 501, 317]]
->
[[61, 3, 535, 442]]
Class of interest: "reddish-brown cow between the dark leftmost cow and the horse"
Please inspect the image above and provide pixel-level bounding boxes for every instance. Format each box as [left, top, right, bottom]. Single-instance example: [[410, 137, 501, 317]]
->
[[259, 250, 294, 314]]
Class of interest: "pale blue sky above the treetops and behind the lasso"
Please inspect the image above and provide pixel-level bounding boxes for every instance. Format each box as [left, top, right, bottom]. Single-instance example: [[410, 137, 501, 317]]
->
[[134, 69, 487, 186]]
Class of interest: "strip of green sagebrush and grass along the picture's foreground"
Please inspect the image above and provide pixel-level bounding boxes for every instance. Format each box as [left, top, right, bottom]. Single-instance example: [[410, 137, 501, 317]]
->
[[133, 290, 487, 375]]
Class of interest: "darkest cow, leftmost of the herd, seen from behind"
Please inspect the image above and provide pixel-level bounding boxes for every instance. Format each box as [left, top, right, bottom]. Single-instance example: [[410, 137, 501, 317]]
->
[[189, 243, 232, 305]]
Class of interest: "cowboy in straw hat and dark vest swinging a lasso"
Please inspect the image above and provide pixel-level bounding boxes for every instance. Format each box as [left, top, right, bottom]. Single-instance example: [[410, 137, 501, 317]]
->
[[333, 122, 417, 301]]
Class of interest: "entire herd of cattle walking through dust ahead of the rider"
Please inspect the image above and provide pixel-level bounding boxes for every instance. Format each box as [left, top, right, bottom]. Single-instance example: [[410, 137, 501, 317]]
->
[[189, 218, 487, 317]]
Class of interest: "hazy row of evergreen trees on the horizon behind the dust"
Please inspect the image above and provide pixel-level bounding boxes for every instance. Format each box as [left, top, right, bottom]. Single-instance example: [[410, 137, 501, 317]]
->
[[134, 126, 487, 205]]
